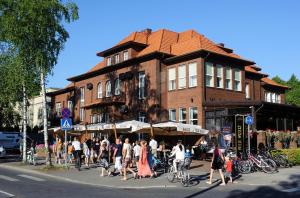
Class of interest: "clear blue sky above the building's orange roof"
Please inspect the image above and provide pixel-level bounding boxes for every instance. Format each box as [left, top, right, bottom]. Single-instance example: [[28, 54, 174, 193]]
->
[[48, 0, 300, 88]]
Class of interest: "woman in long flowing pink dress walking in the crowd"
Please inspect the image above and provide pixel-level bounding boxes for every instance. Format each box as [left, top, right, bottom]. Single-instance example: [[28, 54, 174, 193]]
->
[[138, 140, 153, 178]]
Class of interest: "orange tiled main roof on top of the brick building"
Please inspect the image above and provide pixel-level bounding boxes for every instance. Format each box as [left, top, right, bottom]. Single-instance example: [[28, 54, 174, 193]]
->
[[117, 29, 248, 59]]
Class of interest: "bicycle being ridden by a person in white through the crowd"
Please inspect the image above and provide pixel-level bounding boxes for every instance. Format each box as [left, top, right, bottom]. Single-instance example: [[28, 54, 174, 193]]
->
[[167, 158, 191, 187]]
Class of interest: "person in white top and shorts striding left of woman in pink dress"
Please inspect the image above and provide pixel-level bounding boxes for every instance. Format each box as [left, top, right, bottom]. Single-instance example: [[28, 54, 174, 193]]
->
[[122, 138, 136, 181]]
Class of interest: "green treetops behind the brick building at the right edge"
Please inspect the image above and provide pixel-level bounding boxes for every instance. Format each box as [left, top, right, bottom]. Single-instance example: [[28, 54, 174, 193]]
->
[[273, 74, 300, 106]]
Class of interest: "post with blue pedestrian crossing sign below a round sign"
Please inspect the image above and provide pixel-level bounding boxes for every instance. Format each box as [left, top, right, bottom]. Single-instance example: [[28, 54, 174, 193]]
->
[[60, 108, 72, 166]]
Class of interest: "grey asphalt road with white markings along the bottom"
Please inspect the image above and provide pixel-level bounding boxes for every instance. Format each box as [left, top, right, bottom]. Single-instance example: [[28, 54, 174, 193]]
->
[[0, 168, 300, 198]]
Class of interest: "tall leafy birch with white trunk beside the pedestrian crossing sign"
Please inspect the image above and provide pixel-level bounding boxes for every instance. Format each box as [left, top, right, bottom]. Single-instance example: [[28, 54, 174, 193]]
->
[[0, 0, 78, 164]]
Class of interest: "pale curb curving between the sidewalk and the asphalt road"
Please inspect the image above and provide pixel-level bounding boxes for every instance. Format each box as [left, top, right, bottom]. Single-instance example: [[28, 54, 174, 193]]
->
[[0, 164, 177, 189]]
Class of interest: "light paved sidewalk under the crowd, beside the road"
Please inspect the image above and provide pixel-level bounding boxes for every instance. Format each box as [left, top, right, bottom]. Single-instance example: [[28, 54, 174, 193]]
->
[[0, 161, 300, 188]]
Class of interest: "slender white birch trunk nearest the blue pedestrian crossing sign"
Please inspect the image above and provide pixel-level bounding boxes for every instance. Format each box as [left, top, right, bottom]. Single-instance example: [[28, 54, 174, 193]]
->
[[41, 72, 51, 165]]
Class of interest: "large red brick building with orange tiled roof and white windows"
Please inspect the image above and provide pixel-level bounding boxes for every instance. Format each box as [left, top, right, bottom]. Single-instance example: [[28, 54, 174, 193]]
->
[[49, 29, 300, 135]]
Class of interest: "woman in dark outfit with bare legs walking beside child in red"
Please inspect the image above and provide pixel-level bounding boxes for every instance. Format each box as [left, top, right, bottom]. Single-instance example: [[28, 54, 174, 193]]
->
[[206, 143, 226, 186]]
